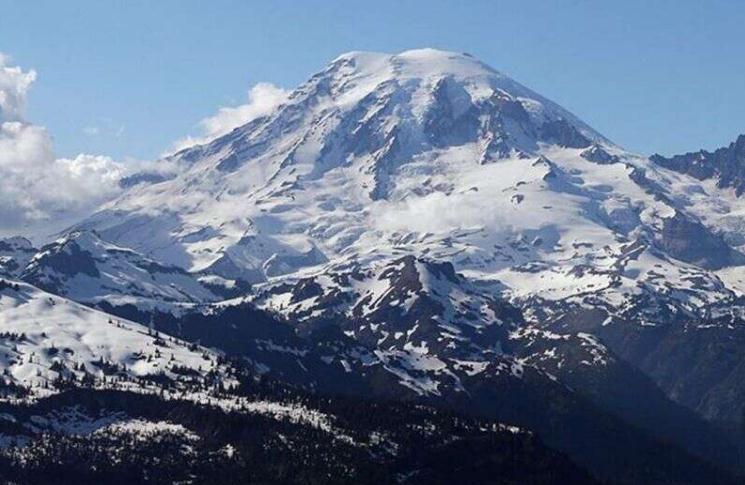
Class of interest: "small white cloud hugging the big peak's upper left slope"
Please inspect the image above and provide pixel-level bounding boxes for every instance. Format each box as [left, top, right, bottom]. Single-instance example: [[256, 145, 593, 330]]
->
[[173, 83, 289, 151]]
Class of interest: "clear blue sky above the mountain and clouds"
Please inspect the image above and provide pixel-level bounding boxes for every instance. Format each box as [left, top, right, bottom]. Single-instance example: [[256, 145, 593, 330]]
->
[[0, 0, 745, 160]]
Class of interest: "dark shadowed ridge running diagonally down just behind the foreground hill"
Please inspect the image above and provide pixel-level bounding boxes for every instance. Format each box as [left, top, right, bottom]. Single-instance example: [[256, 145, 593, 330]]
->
[[72, 294, 736, 483]]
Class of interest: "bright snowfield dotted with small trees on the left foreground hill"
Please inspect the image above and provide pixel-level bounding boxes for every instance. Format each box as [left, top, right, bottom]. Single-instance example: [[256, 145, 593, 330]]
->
[[0, 281, 230, 398]]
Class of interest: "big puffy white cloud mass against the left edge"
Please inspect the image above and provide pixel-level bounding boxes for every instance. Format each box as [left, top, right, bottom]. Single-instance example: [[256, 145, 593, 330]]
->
[[0, 54, 125, 236]]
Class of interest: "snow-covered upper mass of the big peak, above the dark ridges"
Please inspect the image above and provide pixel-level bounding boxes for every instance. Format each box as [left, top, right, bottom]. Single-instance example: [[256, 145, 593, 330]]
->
[[72, 50, 743, 314]]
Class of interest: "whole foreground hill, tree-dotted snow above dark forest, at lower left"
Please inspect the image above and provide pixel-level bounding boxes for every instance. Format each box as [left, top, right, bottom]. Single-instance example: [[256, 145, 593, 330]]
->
[[0, 280, 608, 483]]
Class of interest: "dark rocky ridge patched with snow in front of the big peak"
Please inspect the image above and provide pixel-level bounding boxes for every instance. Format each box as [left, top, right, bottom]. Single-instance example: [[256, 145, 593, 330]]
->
[[246, 256, 731, 461]]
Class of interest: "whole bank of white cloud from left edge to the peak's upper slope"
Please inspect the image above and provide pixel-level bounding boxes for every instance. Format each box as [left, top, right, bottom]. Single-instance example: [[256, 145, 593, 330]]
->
[[0, 53, 289, 241]]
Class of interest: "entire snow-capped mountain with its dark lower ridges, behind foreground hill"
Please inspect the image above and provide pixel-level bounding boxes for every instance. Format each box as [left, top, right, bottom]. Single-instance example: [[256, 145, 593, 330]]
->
[[5, 49, 745, 483]]
